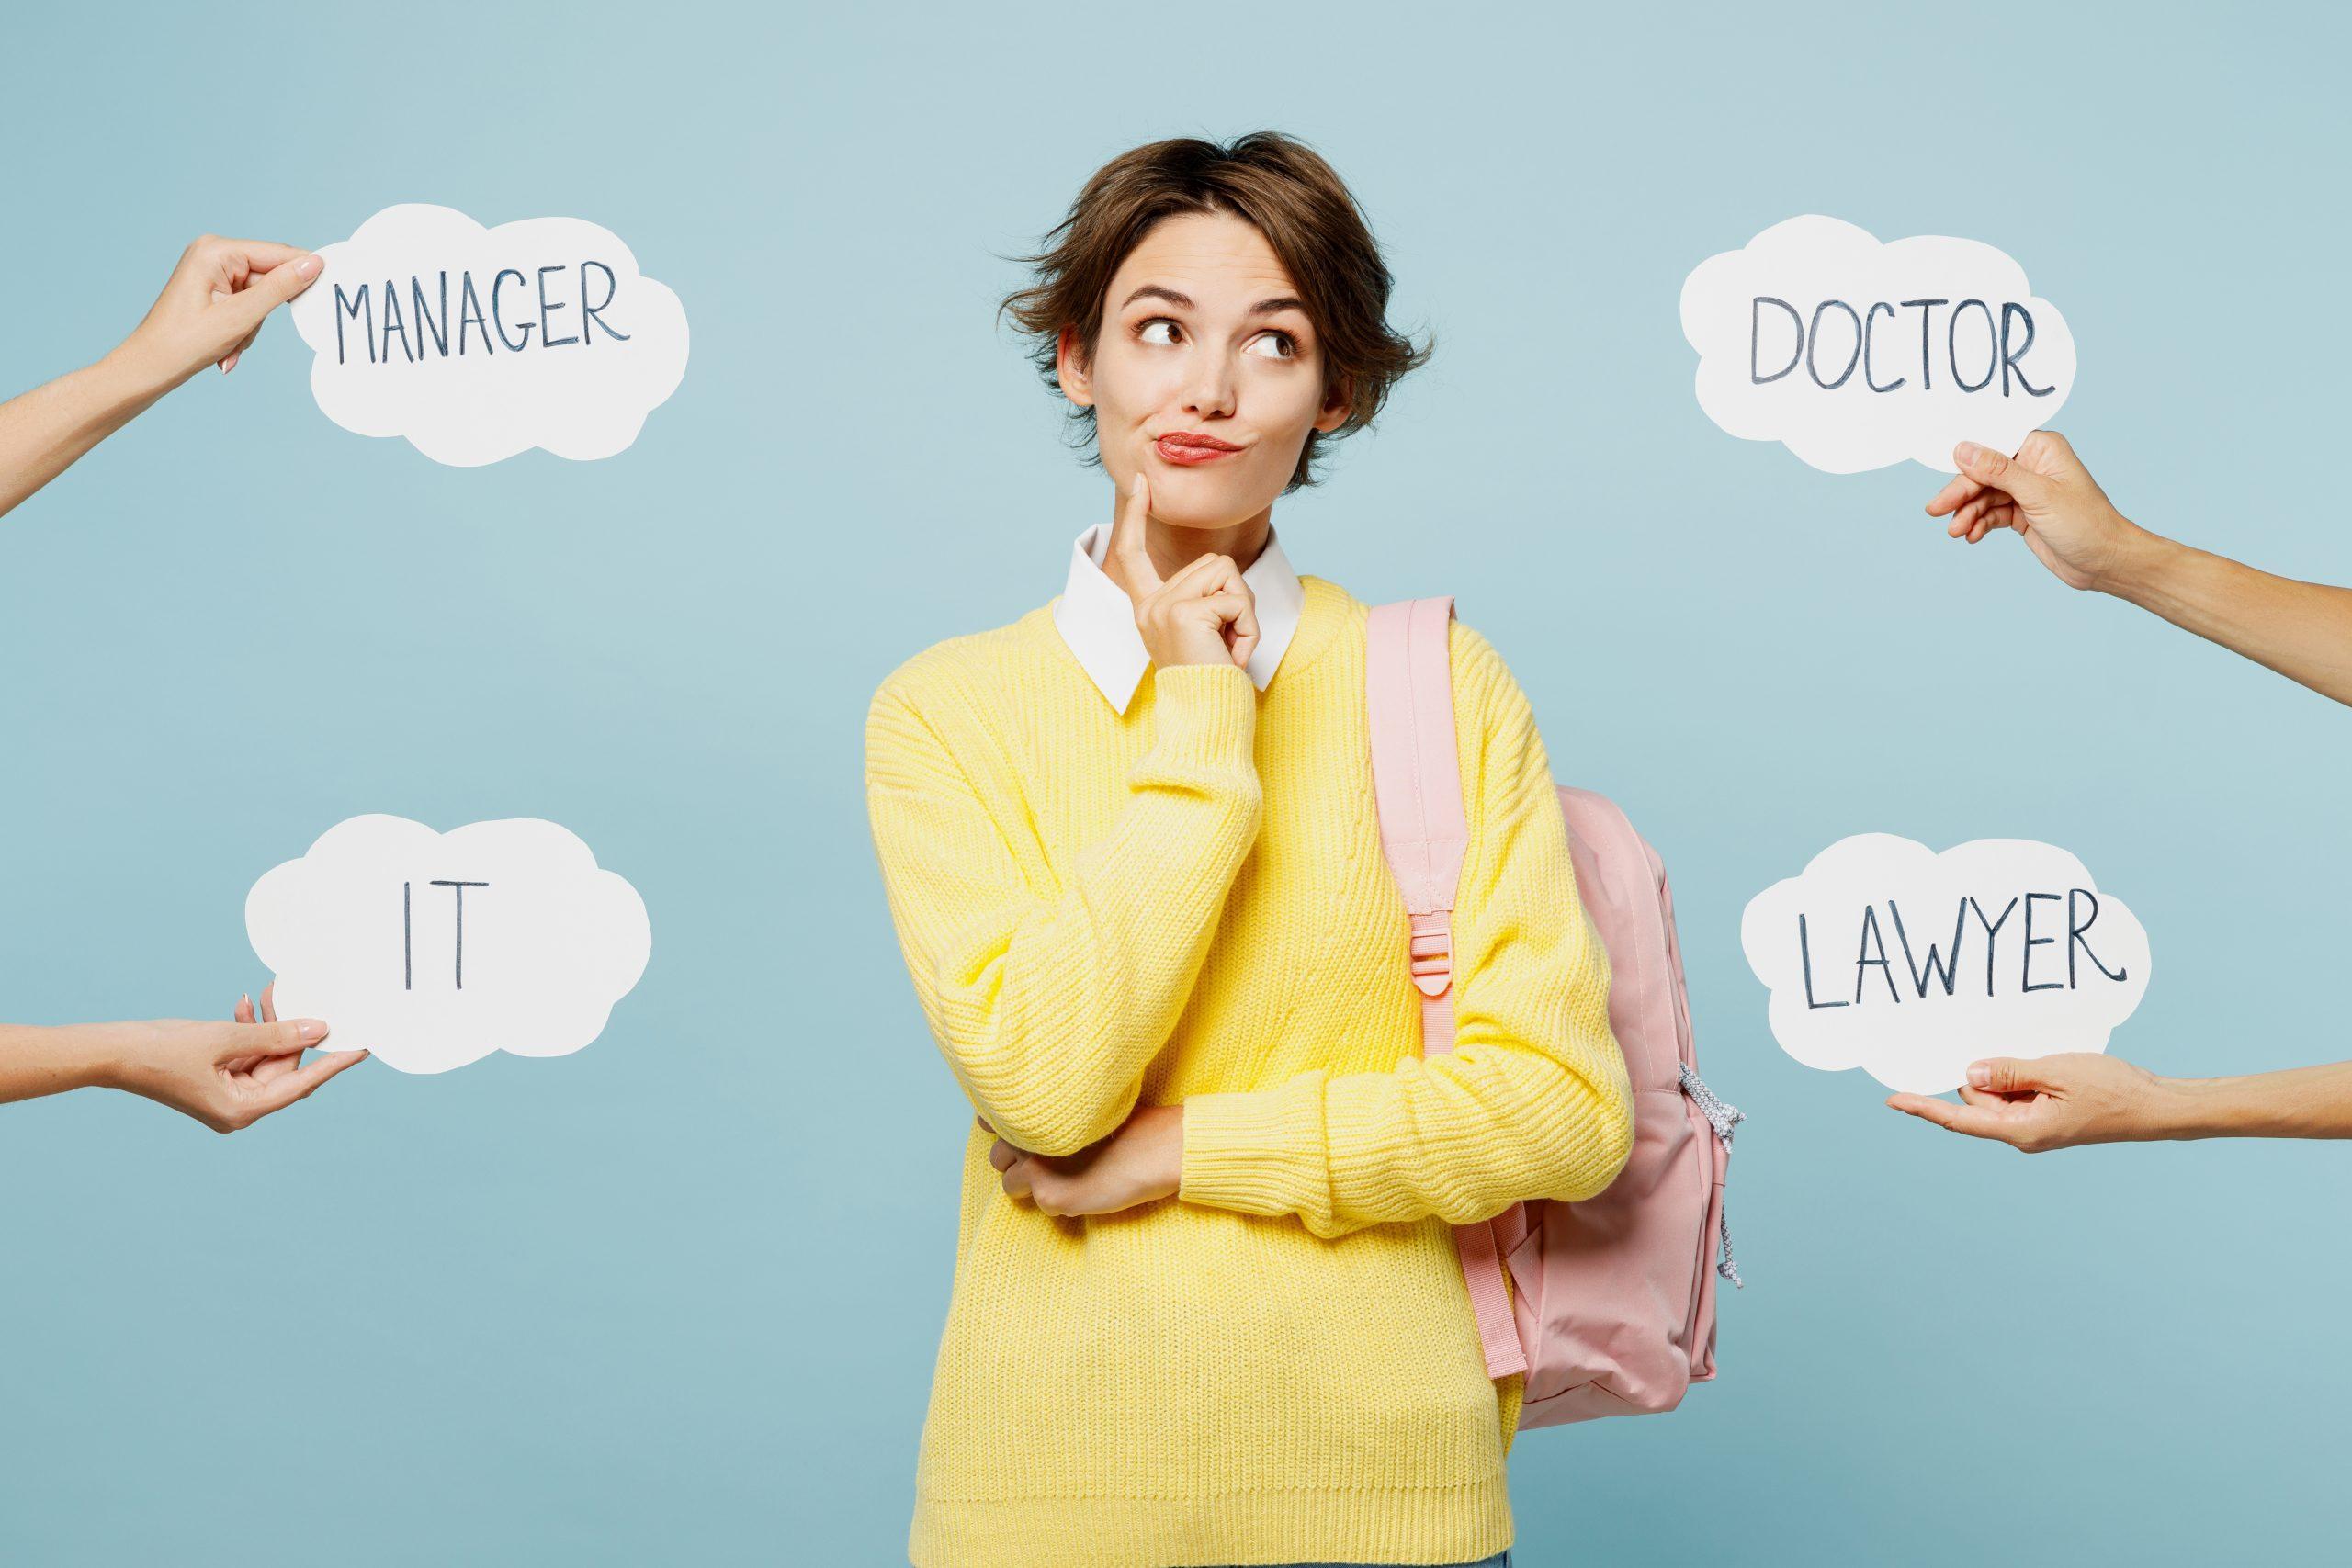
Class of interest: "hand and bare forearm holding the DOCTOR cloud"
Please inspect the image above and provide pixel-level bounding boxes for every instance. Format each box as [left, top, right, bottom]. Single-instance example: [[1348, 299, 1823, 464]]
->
[[1927, 430, 2352, 703]]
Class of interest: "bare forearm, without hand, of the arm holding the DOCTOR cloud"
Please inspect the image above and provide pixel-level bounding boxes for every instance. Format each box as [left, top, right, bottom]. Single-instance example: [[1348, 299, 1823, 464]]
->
[[2100, 531, 2352, 703]]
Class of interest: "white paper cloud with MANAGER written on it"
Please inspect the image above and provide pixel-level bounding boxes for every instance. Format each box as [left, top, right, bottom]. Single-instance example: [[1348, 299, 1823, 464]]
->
[[291, 202, 687, 468]]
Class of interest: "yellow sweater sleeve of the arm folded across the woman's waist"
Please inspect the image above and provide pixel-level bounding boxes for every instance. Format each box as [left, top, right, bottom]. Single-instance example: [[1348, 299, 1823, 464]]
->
[[1179, 621, 1633, 1236]]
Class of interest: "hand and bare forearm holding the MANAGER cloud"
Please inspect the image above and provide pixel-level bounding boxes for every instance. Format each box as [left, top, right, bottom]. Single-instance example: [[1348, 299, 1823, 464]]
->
[[0, 235, 320, 514]]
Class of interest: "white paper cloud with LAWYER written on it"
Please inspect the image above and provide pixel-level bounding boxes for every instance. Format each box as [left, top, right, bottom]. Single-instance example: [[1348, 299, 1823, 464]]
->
[[1740, 832, 2147, 1093]]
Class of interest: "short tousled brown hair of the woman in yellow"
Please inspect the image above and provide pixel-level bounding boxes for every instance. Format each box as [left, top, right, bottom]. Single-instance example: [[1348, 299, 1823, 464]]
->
[[997, 131, 1430, 493]]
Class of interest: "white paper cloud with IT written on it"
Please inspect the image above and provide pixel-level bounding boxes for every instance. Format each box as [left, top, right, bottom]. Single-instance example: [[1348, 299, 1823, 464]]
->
[[244, 816, 654, 1072]]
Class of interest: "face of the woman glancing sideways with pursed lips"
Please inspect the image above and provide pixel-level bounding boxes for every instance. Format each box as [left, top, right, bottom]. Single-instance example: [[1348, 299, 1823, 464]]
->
[[1058, 211, 1348, 529]]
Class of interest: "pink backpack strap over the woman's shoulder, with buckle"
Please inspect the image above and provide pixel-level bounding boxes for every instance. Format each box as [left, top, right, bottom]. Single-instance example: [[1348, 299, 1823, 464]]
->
[[1364, 594, 1526, 1378]]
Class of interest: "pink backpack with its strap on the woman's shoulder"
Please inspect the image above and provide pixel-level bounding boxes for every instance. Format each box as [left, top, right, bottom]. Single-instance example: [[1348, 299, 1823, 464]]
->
[[1364, 594, 1740, 1432]]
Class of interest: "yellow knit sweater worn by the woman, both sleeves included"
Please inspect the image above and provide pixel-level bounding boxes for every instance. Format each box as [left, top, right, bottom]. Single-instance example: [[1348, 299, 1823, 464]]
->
[[865, 576, 1633, 1568]]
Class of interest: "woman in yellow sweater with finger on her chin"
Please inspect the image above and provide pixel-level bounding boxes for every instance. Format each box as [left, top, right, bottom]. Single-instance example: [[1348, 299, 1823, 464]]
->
[[865, 134, 1633, 1568]]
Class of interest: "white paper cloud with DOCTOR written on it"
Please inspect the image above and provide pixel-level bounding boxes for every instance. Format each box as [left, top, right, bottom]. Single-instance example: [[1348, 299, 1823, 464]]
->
[[1681, 214, 2075, 472]]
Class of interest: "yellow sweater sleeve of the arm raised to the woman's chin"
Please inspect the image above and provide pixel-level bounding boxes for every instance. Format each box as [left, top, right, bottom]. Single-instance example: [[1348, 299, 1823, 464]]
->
[[865, 665, 1261, 1155]]
